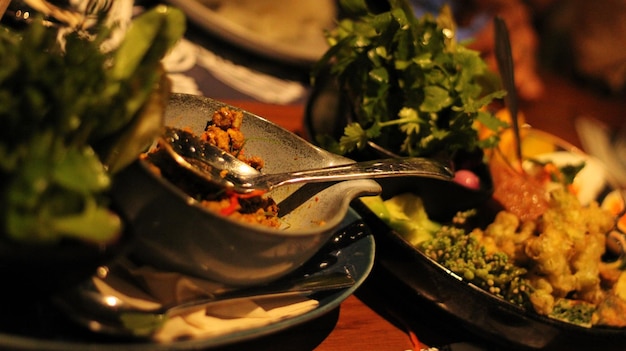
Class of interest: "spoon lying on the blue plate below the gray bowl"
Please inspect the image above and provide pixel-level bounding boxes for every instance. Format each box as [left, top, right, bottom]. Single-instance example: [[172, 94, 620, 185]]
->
[[54, 267, 355, 338]]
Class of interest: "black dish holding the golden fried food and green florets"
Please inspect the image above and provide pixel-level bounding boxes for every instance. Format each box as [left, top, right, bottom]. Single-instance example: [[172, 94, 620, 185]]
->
[[353, 201, 626, 351]]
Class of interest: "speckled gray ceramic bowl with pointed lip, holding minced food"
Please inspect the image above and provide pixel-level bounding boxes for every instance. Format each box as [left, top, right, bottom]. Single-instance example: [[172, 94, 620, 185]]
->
[[113, 94, 381, 286]]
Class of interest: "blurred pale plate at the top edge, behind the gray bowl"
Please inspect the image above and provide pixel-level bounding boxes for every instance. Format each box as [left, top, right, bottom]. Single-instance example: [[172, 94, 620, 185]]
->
[[163, 0, 337, 65]]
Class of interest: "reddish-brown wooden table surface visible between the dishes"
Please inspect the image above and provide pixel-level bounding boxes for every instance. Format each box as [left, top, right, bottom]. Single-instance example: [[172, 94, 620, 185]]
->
[[212, 75, 626, 351]]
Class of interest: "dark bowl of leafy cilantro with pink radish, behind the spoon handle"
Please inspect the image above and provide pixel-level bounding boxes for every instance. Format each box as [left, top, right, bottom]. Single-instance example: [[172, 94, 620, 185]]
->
[[305, 0, 507, 218]]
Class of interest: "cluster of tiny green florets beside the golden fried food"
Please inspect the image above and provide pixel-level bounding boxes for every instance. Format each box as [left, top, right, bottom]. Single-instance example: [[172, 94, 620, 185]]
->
[[417, 226, 531, 307]]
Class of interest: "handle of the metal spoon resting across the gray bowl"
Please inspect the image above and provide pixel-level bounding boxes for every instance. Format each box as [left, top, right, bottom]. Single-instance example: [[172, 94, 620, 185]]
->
[[244, 157, 454, 190]]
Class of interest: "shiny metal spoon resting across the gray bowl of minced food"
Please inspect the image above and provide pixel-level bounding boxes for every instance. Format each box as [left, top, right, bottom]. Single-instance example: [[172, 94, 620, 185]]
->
[[153, 127, 454, 193]]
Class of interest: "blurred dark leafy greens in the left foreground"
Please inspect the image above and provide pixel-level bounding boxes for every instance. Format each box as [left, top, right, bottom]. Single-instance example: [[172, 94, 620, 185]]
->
[[0, 6, 185, 244]]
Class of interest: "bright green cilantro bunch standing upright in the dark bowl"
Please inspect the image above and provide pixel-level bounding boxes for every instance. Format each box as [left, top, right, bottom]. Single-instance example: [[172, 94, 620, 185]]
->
[[313, 0, 504, 157]]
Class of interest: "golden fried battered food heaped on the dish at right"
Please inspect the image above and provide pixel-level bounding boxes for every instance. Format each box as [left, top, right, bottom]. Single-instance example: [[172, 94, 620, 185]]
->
[[473, 188, 626, 323]]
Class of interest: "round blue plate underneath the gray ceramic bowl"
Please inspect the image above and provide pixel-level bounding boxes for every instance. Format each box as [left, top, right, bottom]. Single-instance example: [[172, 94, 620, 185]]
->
[[0, 210, 375, 351]]
